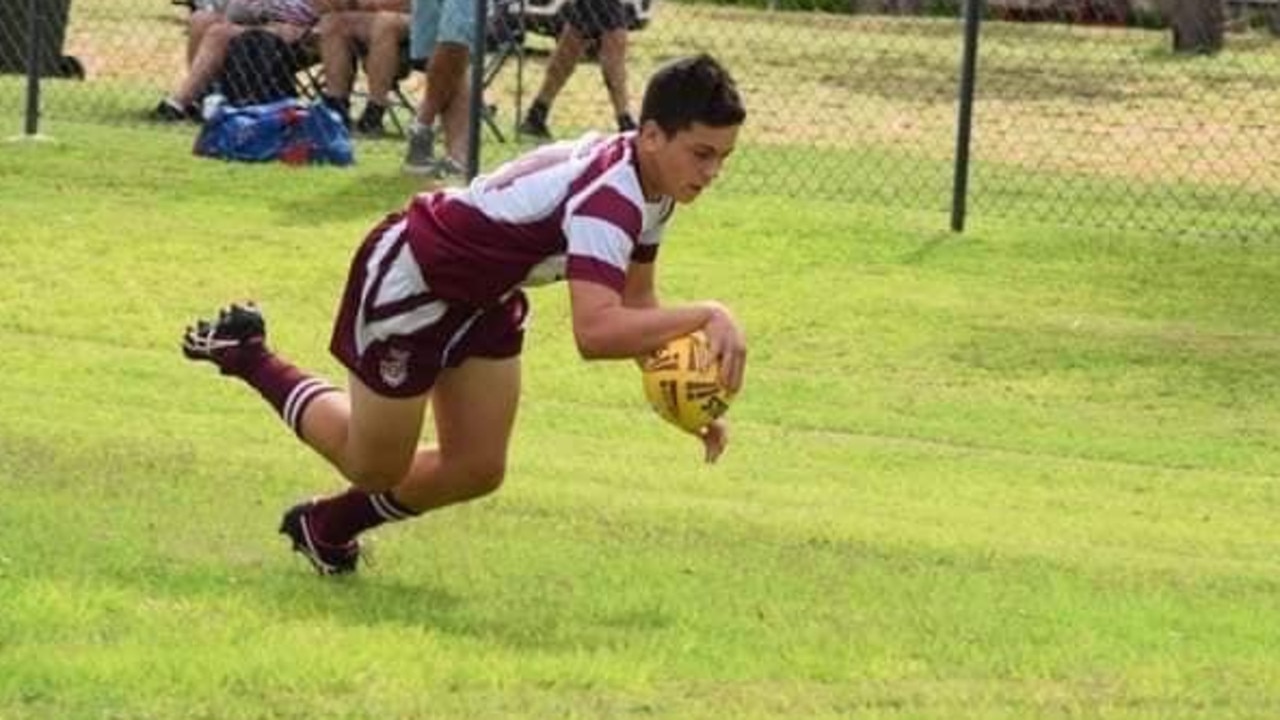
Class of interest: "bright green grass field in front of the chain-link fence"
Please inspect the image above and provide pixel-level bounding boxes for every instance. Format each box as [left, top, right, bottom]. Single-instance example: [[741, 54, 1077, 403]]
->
[[0, 123, 1280, 720]]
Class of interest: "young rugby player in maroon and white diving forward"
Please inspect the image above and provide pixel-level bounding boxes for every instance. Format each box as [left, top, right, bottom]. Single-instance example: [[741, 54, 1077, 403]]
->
[[183, 55, 746, 574]]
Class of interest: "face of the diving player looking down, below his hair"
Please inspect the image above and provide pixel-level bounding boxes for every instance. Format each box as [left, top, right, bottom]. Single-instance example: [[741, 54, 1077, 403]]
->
[[639, 120, 739, 202]]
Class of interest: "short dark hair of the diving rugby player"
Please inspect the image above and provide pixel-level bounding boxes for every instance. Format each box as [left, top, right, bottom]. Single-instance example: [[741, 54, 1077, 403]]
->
[[640, 53, 746, 136]]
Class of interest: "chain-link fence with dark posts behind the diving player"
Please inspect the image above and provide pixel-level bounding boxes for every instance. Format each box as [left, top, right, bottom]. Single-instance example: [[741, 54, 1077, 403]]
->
[[0, 0, 1280, 237]]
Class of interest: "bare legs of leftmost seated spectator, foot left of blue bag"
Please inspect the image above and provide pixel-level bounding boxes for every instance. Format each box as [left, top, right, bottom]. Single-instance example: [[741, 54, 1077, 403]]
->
[[151, 0, 343, 122]]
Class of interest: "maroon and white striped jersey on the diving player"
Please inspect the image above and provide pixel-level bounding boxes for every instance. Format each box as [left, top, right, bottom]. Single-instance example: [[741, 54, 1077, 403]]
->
[[403, 133, 673, 306]]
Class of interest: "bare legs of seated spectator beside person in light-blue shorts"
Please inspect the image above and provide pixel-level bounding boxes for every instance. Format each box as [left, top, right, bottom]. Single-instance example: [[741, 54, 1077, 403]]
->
[[316, 0, 411, 135]]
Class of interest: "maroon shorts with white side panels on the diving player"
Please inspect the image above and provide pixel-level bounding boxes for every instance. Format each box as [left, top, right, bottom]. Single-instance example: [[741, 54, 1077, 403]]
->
[[329, 215, 529, 397]]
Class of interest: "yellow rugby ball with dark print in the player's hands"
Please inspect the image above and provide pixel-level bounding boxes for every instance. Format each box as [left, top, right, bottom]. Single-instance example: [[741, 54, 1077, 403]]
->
[[641, 332, 733, 434]]
